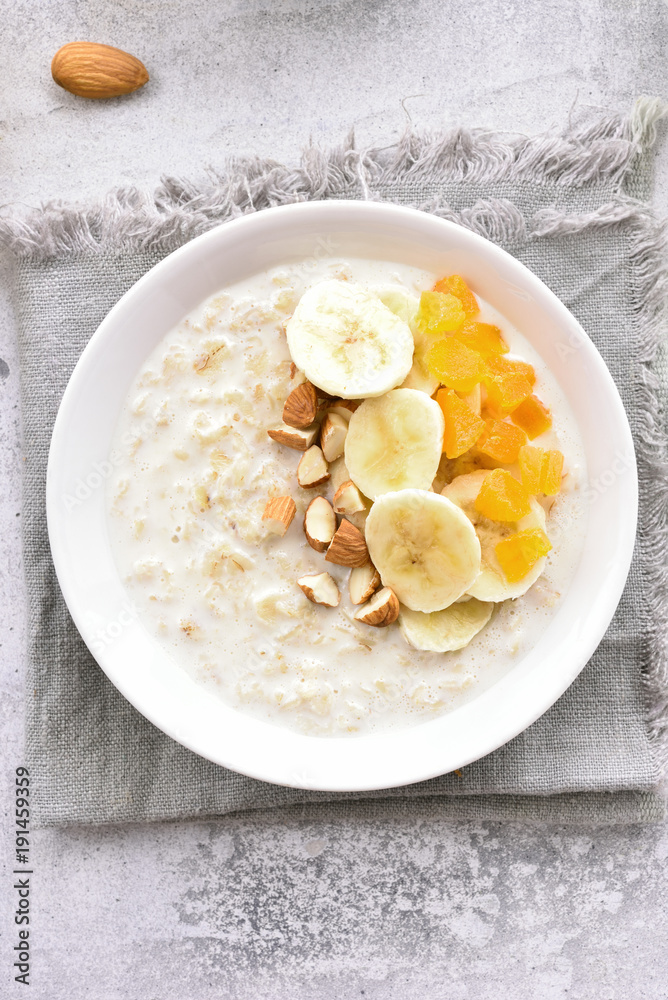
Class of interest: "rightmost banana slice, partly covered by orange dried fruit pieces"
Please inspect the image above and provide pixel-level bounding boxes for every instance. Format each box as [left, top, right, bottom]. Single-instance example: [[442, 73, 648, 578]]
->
[[441, 469, 546, 602]]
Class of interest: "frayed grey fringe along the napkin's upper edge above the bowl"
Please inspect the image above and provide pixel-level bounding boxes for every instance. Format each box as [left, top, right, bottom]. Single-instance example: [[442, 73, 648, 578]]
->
[[0, 97, 668, 261]]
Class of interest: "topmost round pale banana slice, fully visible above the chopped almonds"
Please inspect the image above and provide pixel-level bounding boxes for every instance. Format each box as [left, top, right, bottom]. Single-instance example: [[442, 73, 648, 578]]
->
[[285, 280, 413, 399]]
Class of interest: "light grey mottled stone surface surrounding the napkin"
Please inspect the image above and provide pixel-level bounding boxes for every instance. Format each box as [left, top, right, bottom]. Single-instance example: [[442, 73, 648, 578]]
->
[[0, 0, 668, 1000]]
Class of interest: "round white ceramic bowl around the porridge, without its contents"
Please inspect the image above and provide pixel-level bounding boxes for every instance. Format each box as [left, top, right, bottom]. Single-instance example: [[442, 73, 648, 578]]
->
[[47, 201, 637, 791]]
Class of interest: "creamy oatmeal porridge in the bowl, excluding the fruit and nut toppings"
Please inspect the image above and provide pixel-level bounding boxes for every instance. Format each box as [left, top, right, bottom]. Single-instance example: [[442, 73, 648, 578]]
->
[[109, 259, 586, 736]]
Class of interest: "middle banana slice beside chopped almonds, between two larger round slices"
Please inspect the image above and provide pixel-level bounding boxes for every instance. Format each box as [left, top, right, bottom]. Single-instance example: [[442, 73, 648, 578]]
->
[[345, 389, 445, 500]]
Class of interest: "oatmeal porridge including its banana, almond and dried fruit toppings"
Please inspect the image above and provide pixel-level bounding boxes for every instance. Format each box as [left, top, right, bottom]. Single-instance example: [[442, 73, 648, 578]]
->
[[108, 259, 586, 736]]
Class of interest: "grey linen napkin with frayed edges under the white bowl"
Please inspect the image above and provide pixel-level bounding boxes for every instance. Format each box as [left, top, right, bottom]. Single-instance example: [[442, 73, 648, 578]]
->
[[0, 99, 668, 825]]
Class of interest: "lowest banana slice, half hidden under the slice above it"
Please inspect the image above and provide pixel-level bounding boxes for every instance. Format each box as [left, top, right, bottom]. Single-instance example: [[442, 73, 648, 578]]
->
[[399, 597, 494, 653]]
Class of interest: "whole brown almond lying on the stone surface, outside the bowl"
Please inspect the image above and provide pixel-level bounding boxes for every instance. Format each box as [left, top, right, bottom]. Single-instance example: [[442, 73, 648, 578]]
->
[[51, 42, 148, 99]]
